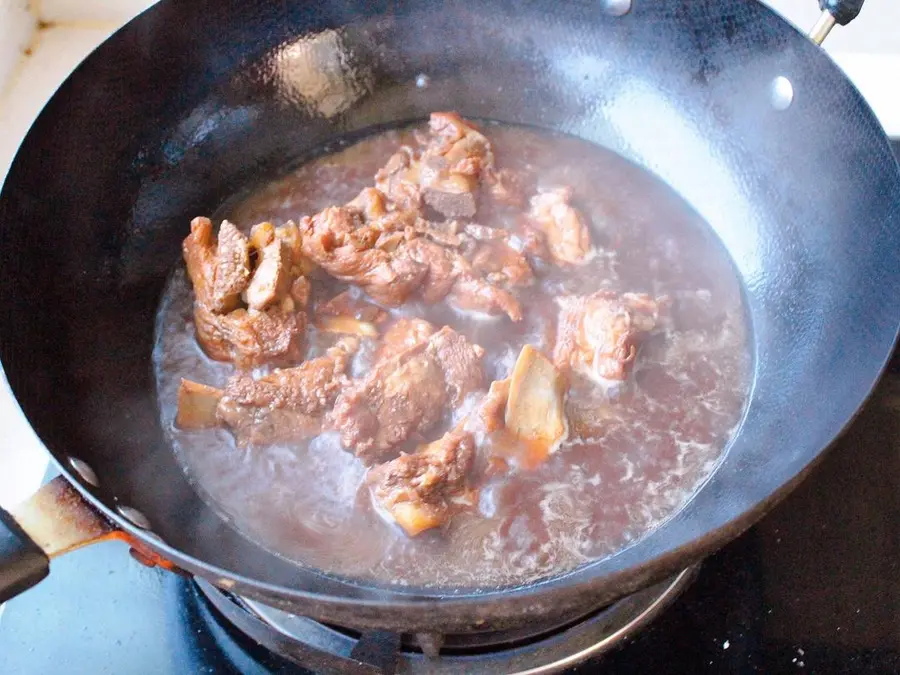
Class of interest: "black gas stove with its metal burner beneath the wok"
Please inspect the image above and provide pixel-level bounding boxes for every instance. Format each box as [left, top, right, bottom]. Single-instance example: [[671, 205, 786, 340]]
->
[[0, 209, 900, 675]]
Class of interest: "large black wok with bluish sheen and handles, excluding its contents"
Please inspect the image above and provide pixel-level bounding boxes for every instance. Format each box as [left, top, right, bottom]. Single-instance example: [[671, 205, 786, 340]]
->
[[0, 0, 900, 632]]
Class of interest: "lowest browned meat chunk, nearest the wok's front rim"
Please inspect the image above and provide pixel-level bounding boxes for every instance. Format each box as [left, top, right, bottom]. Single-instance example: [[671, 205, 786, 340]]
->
[[366, 431, 475, 537]]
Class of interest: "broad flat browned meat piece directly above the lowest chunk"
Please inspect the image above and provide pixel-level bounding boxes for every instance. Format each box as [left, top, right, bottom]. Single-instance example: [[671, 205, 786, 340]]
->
[[333, 326, 484, 462]]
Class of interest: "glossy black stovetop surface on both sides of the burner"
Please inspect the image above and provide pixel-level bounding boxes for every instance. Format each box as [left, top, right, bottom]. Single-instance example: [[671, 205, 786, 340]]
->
[[0, 143, 900, 675]]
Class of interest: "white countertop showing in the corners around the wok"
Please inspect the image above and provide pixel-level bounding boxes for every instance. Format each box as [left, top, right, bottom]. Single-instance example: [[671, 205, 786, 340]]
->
[[0, 0, 900, 508]]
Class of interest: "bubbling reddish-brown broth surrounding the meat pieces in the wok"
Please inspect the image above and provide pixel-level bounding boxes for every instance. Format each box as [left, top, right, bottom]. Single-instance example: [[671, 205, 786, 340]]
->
[[154, 123, 750, 587]]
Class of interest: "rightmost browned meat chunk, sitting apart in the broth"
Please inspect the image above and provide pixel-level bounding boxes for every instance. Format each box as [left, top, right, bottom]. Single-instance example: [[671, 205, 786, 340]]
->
[[553, 291, 667, 381]]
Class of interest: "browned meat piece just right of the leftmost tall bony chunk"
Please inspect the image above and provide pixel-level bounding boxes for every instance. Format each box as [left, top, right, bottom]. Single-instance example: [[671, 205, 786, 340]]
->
[[300, 206, 428, 307]]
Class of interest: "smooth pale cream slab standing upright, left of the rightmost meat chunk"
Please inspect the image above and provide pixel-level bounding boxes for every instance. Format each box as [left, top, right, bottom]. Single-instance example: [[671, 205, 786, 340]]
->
[[506, 345, 568, 455]]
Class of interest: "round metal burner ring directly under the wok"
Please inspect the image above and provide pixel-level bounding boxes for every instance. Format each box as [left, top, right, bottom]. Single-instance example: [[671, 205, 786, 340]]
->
[[197, 567, 697, 675]]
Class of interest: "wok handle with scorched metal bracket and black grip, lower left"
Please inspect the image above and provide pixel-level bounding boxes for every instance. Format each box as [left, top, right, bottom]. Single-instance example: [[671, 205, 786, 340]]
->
[[0, 476, 181, 603]]
